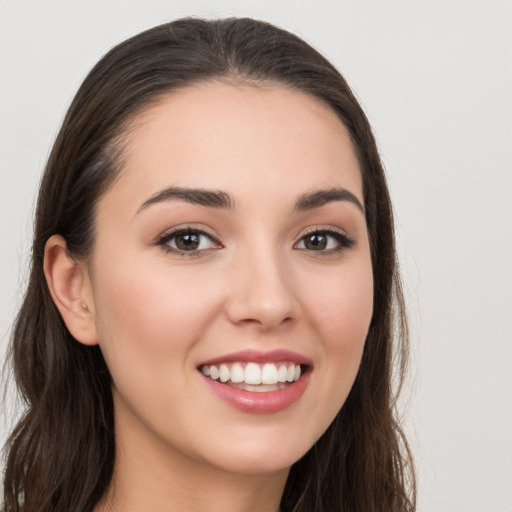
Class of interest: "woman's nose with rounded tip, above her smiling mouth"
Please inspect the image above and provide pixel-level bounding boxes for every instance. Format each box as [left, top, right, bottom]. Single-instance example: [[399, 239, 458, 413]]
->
[[226, 247, 301, 331]]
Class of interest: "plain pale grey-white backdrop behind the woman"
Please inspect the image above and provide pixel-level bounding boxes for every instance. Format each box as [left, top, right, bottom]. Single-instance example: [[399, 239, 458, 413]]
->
[[0, 0, 512, 512]]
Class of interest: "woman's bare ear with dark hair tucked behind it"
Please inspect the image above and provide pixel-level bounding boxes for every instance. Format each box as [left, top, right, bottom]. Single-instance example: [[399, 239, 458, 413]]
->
[[43, 235, 98, 345]]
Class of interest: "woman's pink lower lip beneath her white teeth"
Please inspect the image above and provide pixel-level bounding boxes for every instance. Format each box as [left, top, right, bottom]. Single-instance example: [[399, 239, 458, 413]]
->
[[201, 371, 311, 414]]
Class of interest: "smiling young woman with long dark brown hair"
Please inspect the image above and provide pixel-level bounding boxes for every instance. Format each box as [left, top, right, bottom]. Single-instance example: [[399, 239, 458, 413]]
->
[[4, 19, 414, 512]]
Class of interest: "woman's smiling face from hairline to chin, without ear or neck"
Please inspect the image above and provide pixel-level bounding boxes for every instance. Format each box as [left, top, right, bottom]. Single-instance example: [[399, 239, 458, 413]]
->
[[83, 83, 373, 474]]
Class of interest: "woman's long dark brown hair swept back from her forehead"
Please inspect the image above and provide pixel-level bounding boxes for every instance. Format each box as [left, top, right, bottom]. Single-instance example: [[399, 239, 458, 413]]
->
[[4, 18, 415, 512]]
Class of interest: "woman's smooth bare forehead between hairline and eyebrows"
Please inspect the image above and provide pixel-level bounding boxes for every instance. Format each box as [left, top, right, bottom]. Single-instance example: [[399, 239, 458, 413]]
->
[[100, 83, 363, 213]]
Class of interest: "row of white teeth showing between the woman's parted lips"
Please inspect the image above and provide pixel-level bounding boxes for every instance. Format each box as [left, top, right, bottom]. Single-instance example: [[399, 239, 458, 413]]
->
[[198, 361, 307, 393]]
